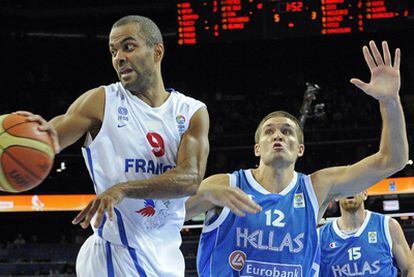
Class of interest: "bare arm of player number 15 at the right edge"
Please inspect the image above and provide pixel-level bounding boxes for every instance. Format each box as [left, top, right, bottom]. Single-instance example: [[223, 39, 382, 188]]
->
[[389, 218, 414, 277]]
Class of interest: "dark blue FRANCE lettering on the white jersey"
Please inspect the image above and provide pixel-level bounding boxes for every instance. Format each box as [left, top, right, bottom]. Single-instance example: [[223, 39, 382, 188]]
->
[[124, 158, 175, 175]]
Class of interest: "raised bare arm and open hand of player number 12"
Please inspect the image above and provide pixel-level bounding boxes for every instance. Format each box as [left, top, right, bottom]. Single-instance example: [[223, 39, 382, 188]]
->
[[311, 41, 408, 216]]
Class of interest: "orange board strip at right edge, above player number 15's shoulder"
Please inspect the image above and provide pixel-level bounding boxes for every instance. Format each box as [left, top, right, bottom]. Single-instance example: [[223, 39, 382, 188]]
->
[[368, 177, 414, 195]]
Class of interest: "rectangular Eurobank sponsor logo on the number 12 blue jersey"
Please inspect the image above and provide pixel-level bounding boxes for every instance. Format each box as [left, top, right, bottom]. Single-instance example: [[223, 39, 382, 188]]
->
[[240, 260, 302, 277]]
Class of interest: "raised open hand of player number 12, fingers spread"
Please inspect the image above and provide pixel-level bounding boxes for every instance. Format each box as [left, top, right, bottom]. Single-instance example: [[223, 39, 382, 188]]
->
[[351, 40, 401, 101]]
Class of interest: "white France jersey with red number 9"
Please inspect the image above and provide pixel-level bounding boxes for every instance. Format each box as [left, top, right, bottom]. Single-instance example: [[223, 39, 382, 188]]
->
[[82, 82, 205, 276]]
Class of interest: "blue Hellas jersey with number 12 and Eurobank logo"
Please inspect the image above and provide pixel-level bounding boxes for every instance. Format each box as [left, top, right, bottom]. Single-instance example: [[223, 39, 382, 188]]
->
[[197, 170, 320, 277]]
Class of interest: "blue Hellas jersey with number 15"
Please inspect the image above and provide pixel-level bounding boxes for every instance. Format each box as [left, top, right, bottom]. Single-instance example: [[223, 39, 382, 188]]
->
[[319, 211, 397, 277]]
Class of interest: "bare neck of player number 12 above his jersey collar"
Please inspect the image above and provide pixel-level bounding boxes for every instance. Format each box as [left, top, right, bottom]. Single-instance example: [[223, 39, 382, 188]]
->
[[252, 164, 295, 193]]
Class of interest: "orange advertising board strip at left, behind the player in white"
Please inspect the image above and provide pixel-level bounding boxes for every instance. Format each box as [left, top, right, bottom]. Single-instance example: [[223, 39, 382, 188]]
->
[[0, 194, 95, 212]]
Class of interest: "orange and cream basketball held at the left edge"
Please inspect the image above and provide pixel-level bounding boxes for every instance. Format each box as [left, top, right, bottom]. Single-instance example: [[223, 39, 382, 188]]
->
[[0, 114, 54, 192]]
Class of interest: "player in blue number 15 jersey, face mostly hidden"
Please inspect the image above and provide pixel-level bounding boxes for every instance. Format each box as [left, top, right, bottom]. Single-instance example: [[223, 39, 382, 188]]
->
[[319, 191, 414, 277]]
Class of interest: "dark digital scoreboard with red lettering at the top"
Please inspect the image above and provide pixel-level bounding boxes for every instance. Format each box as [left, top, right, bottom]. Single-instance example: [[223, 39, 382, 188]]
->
[[177, 0, 414, 44]]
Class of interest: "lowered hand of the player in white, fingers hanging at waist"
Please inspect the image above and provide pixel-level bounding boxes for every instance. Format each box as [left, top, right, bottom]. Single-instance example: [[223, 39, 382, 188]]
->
[[72, 185, 125, 229]]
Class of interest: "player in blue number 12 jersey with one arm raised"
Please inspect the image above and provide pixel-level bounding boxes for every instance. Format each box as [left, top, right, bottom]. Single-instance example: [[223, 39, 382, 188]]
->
[[186, 41, 408, 276]]
